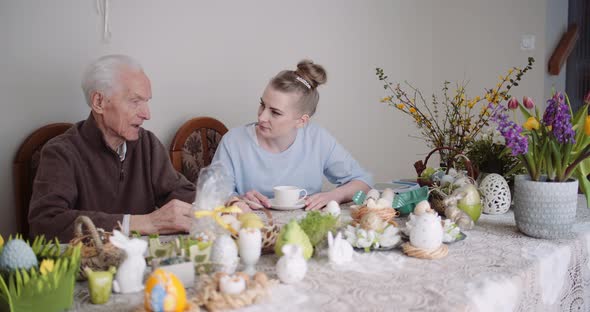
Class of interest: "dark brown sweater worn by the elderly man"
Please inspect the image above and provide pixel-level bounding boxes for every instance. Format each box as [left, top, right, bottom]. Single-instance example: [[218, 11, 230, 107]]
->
[[29, 114, 195, 242]]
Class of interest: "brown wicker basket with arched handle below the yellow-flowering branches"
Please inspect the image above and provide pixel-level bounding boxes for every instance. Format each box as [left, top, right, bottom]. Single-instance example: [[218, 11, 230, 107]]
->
[[414, 147, 477, 215]]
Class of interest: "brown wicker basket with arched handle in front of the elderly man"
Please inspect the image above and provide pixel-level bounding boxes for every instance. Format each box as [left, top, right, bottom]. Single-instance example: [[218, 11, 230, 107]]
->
[[70, 216, 125, 280]]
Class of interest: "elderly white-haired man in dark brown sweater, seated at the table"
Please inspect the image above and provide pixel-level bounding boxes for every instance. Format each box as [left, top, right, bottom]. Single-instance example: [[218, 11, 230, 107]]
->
[[29, 55, 195, 241]]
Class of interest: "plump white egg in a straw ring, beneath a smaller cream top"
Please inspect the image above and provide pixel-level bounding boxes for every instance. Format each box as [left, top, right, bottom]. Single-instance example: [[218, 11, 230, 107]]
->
[[410, 213, 443, 250]]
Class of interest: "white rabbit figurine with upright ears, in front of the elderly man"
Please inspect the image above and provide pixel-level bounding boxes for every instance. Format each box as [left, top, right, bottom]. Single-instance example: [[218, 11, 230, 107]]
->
[[109, 230, 148, 294]]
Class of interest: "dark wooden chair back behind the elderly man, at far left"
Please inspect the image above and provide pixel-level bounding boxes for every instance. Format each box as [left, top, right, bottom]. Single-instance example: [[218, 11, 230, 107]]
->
[[12, 123, 72, 238]]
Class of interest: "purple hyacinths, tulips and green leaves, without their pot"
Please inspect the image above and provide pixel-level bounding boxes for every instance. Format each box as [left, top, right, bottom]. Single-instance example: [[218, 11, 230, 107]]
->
[[493, 92, 590, 203]]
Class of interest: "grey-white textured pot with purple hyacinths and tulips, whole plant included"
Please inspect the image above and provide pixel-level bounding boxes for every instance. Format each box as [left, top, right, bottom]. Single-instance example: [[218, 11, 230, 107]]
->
[[489, 92, 590, 238]]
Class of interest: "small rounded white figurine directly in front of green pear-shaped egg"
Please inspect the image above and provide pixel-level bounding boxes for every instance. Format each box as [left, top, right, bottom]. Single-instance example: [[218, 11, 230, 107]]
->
[[276, 244, 307, 284]]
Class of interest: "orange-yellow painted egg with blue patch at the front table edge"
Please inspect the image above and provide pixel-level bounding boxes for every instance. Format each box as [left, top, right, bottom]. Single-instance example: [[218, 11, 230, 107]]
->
[[143, 269, 186, 312]]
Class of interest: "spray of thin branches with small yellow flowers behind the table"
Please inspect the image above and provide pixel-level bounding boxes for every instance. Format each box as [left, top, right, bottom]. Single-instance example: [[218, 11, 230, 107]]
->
[[376, 57, 534, 163]]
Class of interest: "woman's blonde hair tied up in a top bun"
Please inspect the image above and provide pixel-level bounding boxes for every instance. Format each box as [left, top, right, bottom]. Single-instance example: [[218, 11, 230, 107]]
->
[[270, 60, 328, 116]]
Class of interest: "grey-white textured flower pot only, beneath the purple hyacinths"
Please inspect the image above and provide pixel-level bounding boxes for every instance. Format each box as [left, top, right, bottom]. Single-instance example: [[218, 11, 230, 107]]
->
[[514, 175, 578, 238]]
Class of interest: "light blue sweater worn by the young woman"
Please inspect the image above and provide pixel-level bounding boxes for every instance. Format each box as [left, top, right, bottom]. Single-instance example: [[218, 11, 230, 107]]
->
[[213, 123, 372, 198]]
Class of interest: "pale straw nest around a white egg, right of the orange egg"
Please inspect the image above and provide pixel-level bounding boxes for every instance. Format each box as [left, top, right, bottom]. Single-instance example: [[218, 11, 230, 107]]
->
[[190, 272, 278, 311]]
